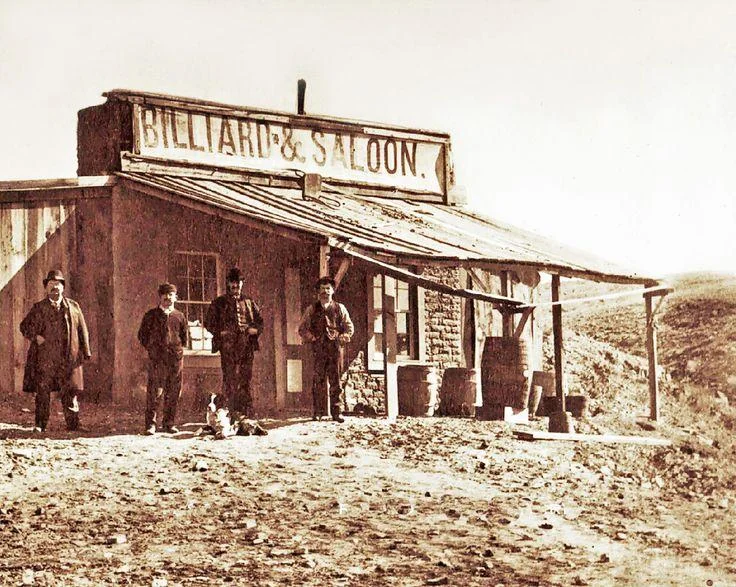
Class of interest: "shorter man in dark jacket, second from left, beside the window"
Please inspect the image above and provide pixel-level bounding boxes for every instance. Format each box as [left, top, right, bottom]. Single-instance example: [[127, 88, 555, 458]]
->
[[138, 283, 189, 435]]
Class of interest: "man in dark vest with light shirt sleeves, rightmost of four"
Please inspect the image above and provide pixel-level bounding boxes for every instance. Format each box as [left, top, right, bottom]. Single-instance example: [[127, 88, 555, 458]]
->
[[299, 277, 354, 422]]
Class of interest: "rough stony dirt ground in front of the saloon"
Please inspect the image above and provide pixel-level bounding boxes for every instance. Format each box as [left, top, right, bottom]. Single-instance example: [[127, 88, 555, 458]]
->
[[0, 396, 736, 586]]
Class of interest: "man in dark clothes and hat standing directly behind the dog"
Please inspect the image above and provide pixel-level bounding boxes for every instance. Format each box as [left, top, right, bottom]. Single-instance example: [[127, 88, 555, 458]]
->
[[204, 268, 263, 420]]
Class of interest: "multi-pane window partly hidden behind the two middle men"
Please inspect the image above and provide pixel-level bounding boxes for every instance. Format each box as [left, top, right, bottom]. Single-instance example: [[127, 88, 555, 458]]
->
[[172, 251, 219, 352]]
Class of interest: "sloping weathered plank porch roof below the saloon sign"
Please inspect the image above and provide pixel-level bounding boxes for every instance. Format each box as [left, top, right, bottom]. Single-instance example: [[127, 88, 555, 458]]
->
[[118, 172, 656, 283]]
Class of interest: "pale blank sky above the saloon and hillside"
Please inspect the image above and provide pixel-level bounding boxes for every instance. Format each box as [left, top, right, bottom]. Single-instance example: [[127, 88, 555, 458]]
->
[[0, 0, 736, 276]]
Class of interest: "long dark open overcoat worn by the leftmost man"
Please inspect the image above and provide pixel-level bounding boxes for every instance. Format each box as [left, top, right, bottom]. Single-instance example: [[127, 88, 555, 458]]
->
[[20, 298, 92, 393]]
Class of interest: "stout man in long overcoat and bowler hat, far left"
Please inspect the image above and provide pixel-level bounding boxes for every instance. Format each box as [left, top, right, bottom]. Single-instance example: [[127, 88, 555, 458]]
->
[[20, 269, 91, 432]]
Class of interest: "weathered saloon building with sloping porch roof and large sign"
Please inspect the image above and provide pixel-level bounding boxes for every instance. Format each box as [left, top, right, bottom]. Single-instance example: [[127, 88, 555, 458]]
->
[[0, 90, 668, 414]]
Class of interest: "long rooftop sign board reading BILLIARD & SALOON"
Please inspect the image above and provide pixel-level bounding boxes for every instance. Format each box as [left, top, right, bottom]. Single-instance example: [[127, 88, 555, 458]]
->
[[133, 102, 449, 195]]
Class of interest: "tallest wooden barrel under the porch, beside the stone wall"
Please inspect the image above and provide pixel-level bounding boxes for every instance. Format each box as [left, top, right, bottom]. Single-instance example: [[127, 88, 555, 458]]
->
[[481, 336, 530, 410]]
